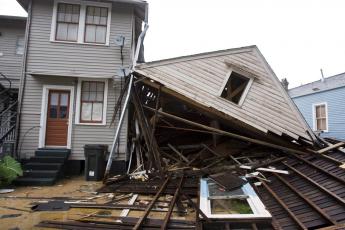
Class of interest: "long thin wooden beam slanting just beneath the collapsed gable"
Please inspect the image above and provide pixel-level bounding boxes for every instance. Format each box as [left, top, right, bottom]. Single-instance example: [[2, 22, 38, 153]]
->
[[144, 106, 312, 154]]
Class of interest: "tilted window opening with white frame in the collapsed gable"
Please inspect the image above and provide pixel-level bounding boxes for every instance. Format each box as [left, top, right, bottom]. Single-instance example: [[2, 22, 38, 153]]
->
[[219, 70, 253, 105]]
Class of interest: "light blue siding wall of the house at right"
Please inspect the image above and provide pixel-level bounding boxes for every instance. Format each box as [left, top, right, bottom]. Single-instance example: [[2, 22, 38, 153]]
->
[[293, 87, 345, 140]]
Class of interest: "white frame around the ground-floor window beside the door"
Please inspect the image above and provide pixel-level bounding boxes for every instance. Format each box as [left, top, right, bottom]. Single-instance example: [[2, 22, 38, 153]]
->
[[75, 78, 108, 126]]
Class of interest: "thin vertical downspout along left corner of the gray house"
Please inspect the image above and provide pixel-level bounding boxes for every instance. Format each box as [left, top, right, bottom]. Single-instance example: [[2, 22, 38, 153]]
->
[[15, 0, 32, 159]]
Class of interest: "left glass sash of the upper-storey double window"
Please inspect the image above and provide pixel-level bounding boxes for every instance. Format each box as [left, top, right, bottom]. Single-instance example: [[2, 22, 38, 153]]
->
[[55, 3, 80, 42]]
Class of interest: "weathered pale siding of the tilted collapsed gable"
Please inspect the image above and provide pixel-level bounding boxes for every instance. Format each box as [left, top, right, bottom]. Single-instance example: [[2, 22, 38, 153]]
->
[[137, 48, 310, 140]]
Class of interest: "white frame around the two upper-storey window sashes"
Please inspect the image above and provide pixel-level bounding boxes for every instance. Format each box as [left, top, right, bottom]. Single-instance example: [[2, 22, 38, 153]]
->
[[50, 0, 112, 46]]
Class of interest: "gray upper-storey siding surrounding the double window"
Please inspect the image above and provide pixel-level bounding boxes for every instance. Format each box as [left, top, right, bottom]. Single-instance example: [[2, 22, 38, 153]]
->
[[27, 0, 133, 78]]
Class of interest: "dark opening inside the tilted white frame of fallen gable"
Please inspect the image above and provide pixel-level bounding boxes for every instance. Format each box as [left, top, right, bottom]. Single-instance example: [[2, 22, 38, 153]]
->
[[221, 71, 250, 104]]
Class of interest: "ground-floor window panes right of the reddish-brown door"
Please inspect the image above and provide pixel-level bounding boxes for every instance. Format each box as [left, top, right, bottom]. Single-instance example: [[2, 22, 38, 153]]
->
[[80, 81, 104, 123]]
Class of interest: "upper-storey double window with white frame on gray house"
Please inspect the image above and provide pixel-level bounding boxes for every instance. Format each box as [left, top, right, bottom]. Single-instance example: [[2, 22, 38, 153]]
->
[[50, 0, 111, 45]]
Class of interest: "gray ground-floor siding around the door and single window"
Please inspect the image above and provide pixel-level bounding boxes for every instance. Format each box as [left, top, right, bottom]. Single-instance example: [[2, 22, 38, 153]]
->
[[19, 75, 127, 160]]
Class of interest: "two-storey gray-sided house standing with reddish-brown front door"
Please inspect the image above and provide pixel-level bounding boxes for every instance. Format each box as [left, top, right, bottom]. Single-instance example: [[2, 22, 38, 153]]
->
[[13, 0, 147, 184]]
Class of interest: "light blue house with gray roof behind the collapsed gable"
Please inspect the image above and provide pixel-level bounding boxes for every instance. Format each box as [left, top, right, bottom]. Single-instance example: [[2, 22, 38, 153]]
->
[[289, 73, 345, 140]]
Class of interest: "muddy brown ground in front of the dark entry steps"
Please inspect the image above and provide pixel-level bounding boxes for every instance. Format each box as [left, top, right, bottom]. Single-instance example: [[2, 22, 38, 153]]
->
[[0, 177, 102, 229]]
